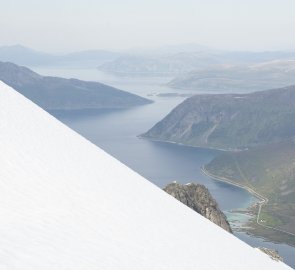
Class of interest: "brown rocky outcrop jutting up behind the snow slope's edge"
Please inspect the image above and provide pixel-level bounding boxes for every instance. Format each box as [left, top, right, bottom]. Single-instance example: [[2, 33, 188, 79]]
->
[[164, 183, 232, 233]]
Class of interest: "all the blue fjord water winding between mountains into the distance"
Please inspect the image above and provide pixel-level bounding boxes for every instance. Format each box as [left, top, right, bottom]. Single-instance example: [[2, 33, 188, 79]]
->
[[35, 68, 295, 267]]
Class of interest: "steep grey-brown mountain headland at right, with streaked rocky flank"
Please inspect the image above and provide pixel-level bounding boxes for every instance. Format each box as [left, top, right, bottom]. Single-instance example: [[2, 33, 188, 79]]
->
[[143, 86, 295, 150]]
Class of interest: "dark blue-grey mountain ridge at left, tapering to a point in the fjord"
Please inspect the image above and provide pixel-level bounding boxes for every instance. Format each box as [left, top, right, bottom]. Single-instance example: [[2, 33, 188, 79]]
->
[[0, 62, 152, 110]]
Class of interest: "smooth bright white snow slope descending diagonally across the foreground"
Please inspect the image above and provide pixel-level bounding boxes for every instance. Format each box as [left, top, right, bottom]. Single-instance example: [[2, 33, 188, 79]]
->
[[0, 82, 290, 270]]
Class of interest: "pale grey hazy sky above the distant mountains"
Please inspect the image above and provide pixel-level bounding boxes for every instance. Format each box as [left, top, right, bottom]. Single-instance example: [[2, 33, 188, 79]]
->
[[0, 0, 295, 52]]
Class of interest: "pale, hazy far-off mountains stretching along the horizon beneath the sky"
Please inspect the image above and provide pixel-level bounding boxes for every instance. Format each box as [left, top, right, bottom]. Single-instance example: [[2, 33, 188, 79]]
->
[[0, 44, 295, 92]]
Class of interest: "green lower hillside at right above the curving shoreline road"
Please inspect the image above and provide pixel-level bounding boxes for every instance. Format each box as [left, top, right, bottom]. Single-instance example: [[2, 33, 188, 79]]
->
[[205, 139, 295, 245]]
